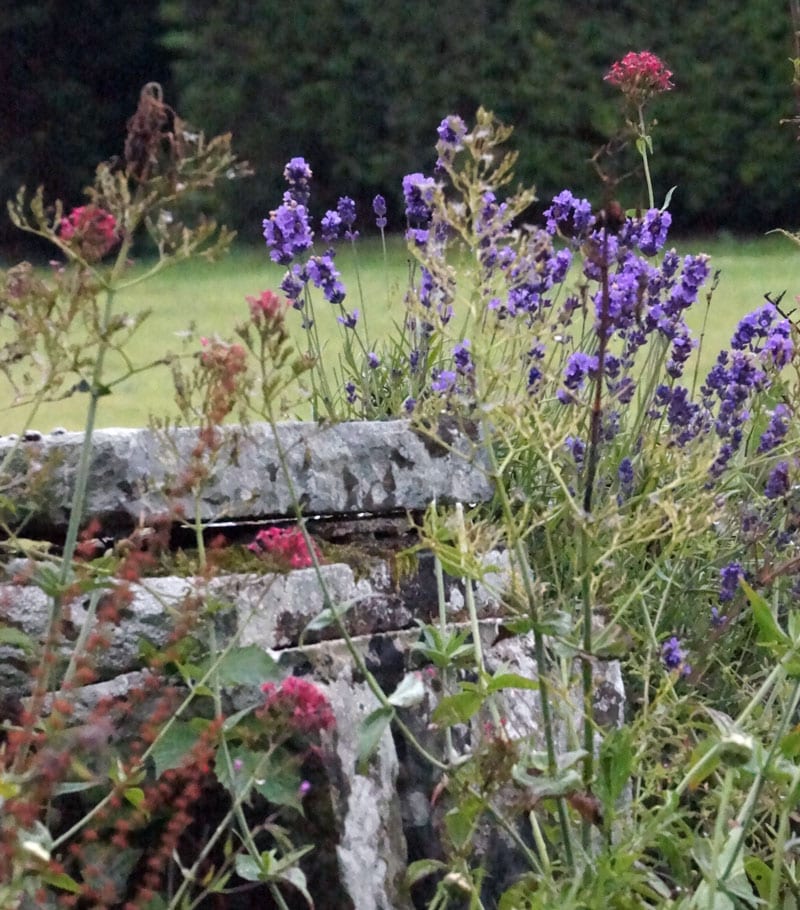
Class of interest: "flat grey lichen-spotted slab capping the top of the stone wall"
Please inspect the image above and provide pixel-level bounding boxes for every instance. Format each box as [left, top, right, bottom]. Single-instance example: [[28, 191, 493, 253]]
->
[[0, 418, 492, 526]]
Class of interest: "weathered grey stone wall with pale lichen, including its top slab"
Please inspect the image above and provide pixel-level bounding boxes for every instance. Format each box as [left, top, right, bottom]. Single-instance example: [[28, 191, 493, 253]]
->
[[0, 422, 624, 910]]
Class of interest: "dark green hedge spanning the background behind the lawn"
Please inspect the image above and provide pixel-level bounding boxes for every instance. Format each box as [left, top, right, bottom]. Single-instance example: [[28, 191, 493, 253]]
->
[[0, 0, 800, 251]]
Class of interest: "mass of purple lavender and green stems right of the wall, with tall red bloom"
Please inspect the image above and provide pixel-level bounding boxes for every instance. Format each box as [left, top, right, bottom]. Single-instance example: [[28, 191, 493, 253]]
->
[[252, 54, 800, 908]]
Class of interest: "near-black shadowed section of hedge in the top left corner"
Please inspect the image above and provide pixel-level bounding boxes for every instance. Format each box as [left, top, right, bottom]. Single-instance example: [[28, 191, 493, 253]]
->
[[0, 0, 171, 258]]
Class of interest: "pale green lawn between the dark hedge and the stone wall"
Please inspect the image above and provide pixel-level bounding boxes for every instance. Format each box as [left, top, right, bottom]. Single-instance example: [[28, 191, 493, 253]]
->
[[0, 235, 800, 433]]
